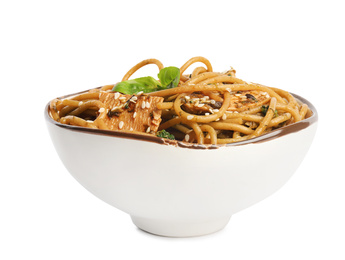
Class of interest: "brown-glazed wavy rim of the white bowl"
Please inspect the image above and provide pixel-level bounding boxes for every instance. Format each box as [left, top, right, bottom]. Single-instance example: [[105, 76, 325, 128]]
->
[[44, 90, 318, 150]]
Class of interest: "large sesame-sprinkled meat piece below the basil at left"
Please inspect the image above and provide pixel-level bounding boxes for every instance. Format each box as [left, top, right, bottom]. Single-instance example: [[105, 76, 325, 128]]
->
[[97, 92, 164, 133]]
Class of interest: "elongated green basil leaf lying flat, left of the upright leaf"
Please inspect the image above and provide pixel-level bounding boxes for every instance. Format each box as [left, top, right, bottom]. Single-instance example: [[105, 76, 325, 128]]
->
[[112, 76, 161, 95]]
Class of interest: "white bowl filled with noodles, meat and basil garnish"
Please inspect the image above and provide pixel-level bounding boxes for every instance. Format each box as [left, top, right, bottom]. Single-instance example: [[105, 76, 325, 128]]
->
[[45, 57, 318, 237]]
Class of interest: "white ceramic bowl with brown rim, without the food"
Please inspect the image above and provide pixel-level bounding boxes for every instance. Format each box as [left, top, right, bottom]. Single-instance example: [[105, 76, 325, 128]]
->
[[45, 92, 318, 237]]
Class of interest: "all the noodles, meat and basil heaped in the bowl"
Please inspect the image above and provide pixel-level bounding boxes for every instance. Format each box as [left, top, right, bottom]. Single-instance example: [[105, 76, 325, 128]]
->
[[49, 57, 311, 145]]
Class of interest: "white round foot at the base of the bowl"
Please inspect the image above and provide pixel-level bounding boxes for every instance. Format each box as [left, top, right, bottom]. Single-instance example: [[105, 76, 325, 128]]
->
[[131, 216, 231, 237]]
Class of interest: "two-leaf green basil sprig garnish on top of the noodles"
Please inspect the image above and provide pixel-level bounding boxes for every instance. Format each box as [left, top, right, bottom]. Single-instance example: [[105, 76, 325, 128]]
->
[[112, 67, 180, 94]]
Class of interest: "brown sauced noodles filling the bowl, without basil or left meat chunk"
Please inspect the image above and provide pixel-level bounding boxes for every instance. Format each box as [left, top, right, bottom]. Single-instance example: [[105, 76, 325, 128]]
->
[[49, 57, 311, 145]]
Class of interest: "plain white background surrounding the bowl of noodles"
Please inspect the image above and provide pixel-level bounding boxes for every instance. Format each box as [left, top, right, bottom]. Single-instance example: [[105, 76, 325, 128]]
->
[[0, 0, 345, 260]]
